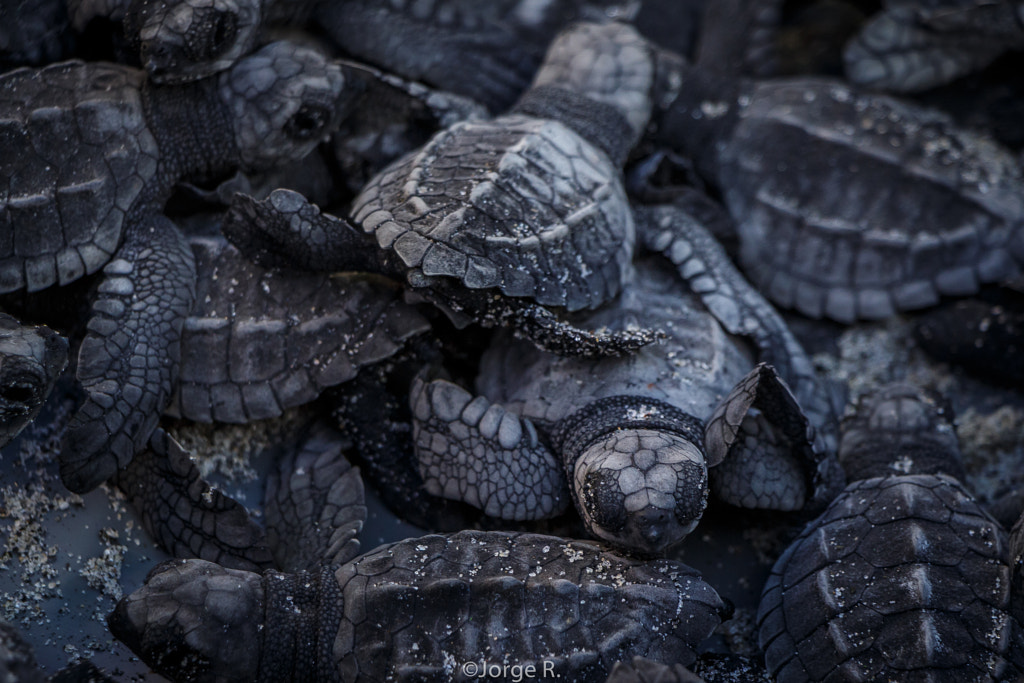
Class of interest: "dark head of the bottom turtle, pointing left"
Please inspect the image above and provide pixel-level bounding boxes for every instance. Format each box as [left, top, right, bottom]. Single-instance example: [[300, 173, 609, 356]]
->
[[106, 559, 265, 681]]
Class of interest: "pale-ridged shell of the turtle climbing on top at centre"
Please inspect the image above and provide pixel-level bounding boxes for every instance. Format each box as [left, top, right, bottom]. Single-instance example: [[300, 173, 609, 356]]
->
[[352, 115, 634, 310]]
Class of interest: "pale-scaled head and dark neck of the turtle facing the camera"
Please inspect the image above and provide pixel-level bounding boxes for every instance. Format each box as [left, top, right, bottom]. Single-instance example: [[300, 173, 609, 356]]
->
[[553, 396, 708, 555]]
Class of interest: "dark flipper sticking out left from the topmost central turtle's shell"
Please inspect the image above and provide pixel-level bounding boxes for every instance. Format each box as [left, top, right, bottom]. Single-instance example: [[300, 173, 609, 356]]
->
[[222, 189, 384, 272]]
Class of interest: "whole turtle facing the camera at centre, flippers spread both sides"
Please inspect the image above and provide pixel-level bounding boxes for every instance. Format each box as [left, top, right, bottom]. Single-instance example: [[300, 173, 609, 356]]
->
[[410, 201, 842, 553]]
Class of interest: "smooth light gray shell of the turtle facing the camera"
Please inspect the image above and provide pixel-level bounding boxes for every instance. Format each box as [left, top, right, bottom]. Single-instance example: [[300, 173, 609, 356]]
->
[[477, 258, 754, 425]]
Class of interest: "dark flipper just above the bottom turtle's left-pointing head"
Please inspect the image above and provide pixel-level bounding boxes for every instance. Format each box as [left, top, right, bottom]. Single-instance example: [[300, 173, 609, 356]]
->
[[115, 429, 273, 571]]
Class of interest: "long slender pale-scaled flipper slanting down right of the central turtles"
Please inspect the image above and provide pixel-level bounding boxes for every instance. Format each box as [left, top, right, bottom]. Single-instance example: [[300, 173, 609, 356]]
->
[[634, 205, 838, 452]]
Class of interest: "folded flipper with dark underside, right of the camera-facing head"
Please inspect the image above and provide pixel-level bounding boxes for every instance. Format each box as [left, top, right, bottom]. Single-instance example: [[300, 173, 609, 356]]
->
[[705, 362, 844, 510]]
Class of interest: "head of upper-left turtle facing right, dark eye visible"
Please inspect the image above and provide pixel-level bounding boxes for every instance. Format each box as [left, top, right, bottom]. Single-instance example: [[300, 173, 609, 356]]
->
[[219, 41, 355, 171]]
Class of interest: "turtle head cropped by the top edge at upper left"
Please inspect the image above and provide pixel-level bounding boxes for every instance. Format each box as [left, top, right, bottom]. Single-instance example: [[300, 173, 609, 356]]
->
[[124, 0, 261, 84]]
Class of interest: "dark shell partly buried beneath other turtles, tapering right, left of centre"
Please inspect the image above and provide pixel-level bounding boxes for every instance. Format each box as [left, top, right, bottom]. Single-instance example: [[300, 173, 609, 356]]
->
[[166, 238, 429, 423]]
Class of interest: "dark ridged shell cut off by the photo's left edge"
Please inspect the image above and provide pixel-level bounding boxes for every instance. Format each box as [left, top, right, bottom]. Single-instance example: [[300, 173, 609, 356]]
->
[[0, 61, 159, 293]]
